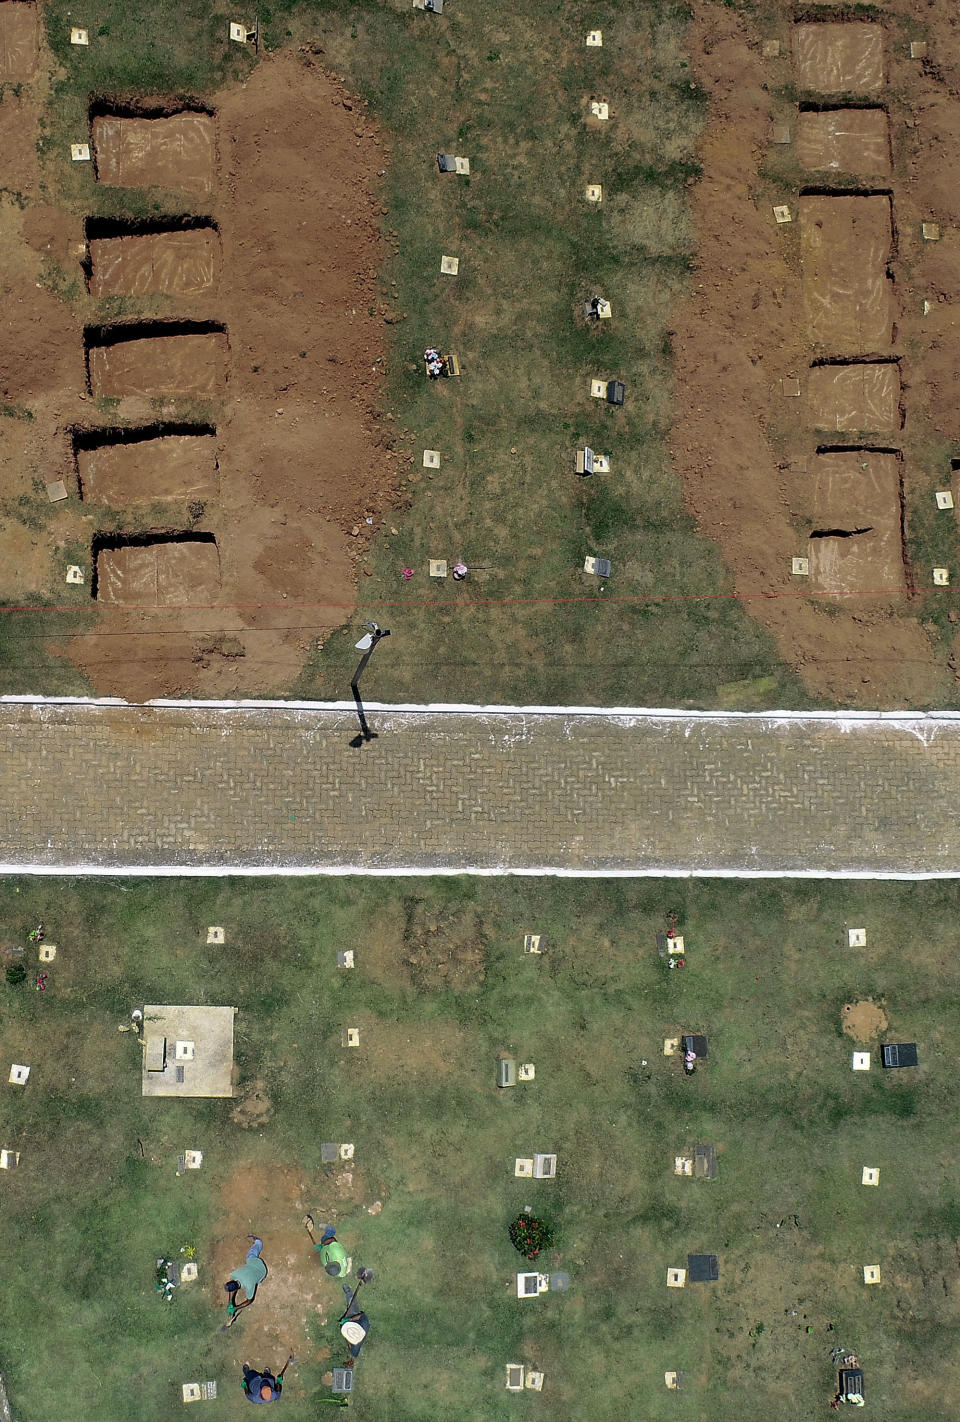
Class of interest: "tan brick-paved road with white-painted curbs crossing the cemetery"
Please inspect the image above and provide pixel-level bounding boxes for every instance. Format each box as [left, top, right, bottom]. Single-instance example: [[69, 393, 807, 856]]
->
[[0, 702, 960, 875]]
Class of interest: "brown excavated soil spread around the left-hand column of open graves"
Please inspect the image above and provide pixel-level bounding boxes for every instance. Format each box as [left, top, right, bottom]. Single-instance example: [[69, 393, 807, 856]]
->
[[0, 51, 400, 700]]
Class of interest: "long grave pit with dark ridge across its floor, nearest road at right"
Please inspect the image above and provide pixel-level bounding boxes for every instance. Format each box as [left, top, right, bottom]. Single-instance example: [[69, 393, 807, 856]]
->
[[808, 449, 907, 597]]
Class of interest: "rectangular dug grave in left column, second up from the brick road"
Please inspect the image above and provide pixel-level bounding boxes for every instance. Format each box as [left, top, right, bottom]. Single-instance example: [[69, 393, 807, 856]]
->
[[74, 425, 220, 509]]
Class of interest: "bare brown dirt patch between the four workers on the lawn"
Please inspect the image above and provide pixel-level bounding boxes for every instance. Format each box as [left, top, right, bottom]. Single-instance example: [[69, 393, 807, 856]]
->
[[209, 1165, 375, 1396]]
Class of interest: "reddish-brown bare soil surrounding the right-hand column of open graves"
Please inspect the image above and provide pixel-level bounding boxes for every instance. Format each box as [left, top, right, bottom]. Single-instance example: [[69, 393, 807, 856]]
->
[[671, 0, 960, 705]]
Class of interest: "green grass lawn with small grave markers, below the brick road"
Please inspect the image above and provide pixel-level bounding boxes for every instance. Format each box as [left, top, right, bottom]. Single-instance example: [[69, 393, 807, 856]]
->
[[0, 879, 960, 1422]]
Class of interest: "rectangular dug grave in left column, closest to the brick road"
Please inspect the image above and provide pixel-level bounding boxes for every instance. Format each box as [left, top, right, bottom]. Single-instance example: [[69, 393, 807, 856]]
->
[[90, 533, 220, 607]]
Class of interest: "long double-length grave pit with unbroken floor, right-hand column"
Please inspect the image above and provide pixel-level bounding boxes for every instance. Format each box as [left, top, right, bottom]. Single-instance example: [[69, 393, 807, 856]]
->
[[799, 193, 896, 356]]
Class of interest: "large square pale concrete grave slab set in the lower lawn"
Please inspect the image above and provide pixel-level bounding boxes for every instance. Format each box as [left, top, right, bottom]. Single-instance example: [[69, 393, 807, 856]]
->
[[141, 1003, 236, 1096]]
